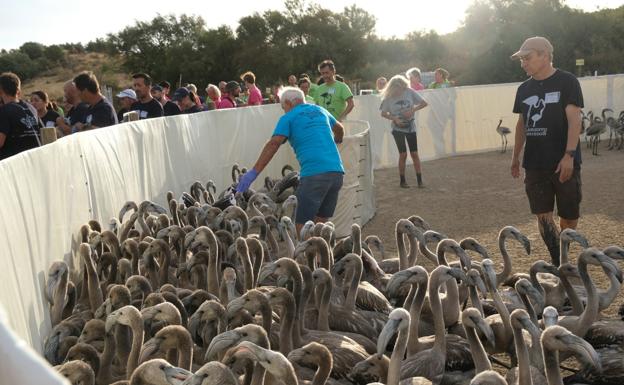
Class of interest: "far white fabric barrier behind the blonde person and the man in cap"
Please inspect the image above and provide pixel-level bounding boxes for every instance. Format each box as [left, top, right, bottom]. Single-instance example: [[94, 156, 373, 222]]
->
[[349, 75, 624, 169]]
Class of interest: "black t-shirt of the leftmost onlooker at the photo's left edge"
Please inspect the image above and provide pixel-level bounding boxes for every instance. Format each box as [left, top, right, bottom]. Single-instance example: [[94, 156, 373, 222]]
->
[[0, 100, 41, 159]]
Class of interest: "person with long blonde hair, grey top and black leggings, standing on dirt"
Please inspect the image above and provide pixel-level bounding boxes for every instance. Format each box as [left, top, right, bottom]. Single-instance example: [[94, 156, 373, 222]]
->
[[379, 75, 427, 188]]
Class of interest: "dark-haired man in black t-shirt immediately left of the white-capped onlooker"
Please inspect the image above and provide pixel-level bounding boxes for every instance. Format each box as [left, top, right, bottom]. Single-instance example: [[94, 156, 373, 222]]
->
[[74, 72, 117, 131]]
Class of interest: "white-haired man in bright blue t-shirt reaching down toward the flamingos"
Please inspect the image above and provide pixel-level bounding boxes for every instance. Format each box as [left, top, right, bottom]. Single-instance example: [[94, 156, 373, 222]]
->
[[237, 87, 344, 234]]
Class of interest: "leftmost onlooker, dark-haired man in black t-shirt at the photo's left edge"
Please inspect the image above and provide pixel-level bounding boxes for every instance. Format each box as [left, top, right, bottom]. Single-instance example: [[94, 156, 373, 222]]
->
[[0, 72, 41, 160]]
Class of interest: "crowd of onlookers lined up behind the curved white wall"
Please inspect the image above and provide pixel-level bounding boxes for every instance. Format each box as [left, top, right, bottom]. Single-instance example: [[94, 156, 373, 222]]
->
[[0, 60, 360, 160]]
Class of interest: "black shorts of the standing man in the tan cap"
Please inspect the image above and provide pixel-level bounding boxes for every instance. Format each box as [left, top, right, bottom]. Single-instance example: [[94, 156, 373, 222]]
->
[[524, 169, 582, 220]]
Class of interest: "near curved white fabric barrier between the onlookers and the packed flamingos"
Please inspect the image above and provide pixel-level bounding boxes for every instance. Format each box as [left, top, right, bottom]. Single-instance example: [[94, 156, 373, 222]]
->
[[0, 105, 374, 351]]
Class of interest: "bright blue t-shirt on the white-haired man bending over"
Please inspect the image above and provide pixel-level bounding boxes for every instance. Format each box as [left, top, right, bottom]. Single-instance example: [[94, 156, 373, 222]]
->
[[273, 103, 344, 177]]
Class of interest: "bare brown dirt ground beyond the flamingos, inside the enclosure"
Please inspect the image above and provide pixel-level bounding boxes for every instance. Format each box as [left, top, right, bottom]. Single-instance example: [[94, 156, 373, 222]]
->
[[363, 143, 624, 316]]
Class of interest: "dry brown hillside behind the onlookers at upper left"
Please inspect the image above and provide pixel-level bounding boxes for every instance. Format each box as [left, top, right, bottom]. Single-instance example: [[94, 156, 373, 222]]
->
[[22, 52, 132, 102]]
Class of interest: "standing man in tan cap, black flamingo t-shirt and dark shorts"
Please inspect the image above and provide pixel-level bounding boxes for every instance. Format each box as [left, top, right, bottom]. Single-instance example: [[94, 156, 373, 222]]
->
[[511, 37, 583, 266]]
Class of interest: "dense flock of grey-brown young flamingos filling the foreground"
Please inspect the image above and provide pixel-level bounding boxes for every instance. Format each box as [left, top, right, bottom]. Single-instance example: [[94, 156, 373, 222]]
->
[[39, 167, 624, 385]]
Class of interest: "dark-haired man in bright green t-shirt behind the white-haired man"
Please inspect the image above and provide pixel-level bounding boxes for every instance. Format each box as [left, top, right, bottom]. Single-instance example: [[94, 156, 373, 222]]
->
[[314, 60, 353, 121]]
